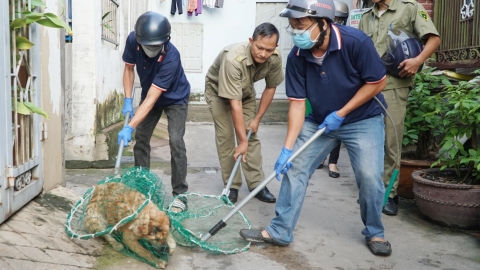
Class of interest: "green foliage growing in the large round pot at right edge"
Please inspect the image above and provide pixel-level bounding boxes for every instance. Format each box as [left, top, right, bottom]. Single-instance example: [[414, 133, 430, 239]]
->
[[433, 69, 480, 184]]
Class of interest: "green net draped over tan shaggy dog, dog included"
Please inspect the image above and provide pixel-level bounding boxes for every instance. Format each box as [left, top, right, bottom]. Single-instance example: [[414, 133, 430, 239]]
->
[[65, 167, 175, 268]]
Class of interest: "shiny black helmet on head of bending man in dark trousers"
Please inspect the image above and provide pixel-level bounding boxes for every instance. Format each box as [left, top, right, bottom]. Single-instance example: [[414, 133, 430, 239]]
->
[[135, 11, 172, 45]]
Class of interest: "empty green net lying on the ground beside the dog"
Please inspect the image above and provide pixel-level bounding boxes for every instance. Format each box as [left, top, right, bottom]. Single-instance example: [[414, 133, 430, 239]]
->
[[167, 193, 251, 254]]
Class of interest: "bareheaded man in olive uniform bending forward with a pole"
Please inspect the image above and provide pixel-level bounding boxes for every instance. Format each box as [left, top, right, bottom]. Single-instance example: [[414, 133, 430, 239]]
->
[[205, 23, 283, 203]]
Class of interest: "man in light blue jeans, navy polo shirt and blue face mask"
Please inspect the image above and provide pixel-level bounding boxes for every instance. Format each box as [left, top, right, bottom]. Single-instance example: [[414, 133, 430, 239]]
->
[[240, 0, 392, 256]]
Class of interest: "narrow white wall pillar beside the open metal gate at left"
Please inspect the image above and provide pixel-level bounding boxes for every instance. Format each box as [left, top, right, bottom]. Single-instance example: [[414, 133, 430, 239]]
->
[[65, 1, 96, 160]]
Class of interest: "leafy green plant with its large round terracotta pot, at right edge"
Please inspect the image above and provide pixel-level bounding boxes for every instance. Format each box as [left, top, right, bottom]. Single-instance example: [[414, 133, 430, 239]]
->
[[412, 70, 480, 229]]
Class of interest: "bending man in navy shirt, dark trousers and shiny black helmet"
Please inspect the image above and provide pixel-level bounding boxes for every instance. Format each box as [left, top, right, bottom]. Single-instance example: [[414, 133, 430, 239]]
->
[[118, 11, 190, 212]]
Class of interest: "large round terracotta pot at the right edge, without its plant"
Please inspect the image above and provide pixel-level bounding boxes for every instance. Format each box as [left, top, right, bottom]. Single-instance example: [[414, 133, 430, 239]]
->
[[412, 168, 480, 229]]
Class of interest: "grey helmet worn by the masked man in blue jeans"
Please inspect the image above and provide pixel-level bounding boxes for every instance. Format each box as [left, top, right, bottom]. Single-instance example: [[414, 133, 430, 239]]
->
[[280, 0, 335, 21]]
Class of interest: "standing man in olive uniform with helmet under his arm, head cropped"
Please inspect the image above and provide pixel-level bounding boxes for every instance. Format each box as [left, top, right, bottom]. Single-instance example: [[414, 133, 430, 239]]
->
[[359, 0, 440, 215]]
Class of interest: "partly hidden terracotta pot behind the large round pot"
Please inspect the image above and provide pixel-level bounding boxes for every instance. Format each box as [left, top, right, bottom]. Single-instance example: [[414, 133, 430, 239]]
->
[[397, 159, 434, 199]]
